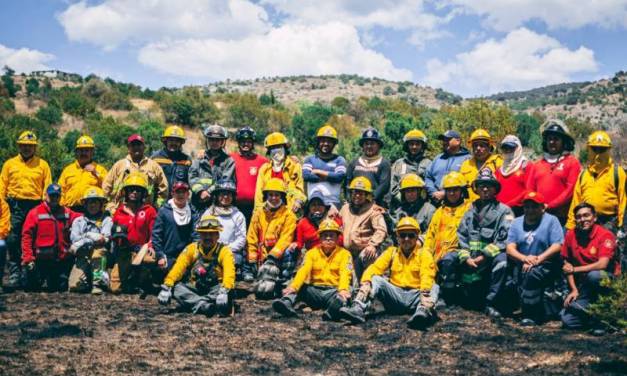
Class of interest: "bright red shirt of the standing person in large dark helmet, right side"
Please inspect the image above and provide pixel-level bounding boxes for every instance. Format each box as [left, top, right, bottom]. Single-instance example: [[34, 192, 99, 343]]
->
[[527, 154, 581, 221]]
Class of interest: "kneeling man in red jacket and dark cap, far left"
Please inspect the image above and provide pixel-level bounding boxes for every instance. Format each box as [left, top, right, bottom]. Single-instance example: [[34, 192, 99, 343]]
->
[[22, 184, 80, 292]]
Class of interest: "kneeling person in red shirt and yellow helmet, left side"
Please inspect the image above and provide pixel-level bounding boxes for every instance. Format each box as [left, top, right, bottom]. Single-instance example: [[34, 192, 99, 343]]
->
[[109, 172, 156, 293]]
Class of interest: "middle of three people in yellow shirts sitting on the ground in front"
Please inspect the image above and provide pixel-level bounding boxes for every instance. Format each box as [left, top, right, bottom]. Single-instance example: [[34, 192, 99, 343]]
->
[[272, 219, 353, 320]]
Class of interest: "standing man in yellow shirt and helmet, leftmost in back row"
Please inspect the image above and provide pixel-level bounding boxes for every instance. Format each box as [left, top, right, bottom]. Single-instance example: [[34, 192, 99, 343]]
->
[[0, 131, 52, 292]]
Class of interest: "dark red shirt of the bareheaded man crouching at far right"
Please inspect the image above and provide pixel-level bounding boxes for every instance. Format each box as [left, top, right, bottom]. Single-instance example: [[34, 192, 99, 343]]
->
[[561, 224, 620, 275]]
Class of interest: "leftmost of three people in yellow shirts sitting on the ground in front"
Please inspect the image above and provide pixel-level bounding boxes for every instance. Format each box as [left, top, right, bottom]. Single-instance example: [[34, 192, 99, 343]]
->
[[158, 215, 235, 316]]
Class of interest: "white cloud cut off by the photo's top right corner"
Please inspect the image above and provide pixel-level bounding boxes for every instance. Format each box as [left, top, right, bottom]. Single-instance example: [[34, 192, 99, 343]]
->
[[448, 0, 627, 31]]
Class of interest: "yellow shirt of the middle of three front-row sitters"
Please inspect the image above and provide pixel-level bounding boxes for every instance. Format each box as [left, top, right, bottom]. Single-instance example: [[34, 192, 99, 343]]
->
[[290, 246, 353, 291]]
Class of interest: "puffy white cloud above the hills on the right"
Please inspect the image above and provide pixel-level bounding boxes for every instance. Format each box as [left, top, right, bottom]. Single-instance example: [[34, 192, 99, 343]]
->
[[425, 28, 598, 95]]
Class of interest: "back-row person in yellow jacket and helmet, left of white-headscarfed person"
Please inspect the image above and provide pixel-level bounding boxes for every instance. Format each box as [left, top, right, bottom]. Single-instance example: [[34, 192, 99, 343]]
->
[[459, 129, 503, 202]]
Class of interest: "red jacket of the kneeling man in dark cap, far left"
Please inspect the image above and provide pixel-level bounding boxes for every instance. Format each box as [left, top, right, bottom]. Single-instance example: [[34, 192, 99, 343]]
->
[[22, 202, 81, 265]]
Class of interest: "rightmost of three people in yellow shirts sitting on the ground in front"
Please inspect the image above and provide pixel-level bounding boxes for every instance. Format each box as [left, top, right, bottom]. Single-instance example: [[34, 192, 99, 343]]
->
[[341, 217, 439, 328]]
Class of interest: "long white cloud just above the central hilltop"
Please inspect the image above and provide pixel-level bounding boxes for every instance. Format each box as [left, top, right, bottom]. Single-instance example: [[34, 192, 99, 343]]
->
[[139, 22, 412, 80]]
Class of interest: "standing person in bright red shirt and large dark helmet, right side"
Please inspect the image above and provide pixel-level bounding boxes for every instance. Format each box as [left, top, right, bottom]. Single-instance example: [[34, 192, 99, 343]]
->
[[527, 119, 581, 225]]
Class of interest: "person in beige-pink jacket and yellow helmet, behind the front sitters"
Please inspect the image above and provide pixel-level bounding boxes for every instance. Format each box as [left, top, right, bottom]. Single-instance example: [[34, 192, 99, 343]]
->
[[340, 176, 388, 278]]
